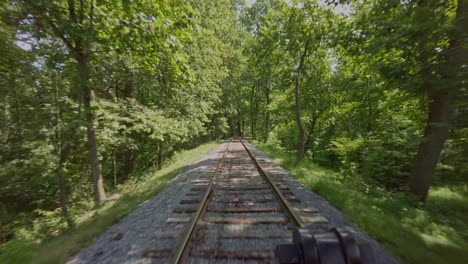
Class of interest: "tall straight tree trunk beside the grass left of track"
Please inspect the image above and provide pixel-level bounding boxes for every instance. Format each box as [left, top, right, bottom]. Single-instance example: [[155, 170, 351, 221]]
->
[[78, 54, 106, 206]]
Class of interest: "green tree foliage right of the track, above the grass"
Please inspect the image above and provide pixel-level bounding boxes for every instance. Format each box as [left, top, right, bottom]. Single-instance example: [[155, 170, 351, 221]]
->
[[238, 1, 466, 198]]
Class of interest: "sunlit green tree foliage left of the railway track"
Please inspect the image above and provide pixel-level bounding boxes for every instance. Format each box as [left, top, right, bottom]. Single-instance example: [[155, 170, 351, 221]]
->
[[0, 0, 240, 248]]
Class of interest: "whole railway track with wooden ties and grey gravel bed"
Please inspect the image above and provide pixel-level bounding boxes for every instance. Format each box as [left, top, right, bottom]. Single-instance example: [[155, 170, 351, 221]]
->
[[68, 140, 388, 264]]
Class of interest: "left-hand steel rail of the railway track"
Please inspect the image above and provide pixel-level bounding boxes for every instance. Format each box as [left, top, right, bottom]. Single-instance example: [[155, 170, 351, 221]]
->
[[172, 140, 231, 264]]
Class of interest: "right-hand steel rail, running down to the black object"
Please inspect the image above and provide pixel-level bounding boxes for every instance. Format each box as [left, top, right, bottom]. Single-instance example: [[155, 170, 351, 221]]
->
[[240, 139, 305, 228]]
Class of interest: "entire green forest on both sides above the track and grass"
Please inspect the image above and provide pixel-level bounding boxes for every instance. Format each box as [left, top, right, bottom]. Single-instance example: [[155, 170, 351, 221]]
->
[[0, 0, 468, 262]]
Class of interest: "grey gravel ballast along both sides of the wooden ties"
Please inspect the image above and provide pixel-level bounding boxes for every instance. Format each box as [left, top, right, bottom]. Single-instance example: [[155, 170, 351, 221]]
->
[[68, 143, 400, 264]]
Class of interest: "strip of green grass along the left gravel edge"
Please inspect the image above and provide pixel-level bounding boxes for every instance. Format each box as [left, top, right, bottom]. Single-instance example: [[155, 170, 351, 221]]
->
[[0, 143, 218, 263]]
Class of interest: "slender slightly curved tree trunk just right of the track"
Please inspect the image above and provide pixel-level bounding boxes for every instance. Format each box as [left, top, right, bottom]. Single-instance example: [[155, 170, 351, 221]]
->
[[294, 40, 309, 165]]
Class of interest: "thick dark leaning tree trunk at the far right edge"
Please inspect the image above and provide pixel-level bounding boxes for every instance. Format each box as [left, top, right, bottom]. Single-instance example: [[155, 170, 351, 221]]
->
[[409, 0, 468, 202]]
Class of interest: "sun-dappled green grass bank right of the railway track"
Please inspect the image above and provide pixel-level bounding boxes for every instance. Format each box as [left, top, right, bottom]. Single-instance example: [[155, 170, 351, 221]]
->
[[257, 144, 468, 264]]
